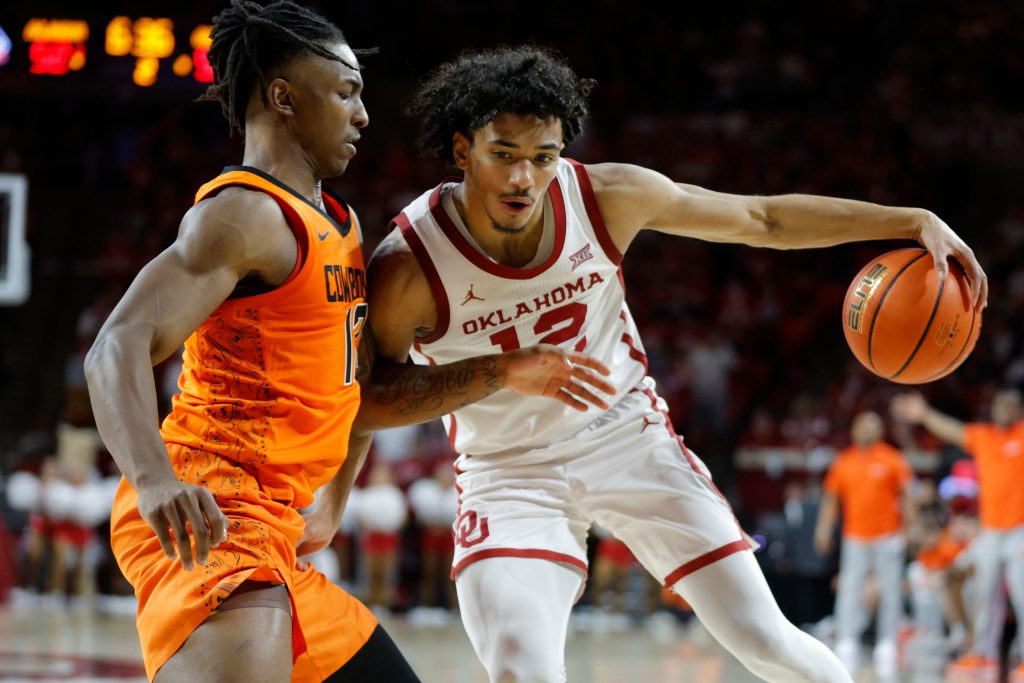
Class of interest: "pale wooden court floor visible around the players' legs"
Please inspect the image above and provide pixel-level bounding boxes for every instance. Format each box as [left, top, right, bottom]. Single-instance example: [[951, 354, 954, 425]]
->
[[0, 600, 942, 683]]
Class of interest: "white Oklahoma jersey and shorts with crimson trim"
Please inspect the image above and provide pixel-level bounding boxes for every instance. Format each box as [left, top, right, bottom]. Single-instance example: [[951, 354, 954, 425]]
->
[[395, 160, 749, 592]]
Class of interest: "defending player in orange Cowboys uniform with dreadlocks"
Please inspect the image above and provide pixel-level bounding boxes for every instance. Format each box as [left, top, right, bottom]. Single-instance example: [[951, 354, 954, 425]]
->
[[86, 6, 607, 683]]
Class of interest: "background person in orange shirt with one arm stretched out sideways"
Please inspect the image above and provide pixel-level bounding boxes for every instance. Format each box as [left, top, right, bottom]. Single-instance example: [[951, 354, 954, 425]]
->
[[892, 389, 1024, 683]]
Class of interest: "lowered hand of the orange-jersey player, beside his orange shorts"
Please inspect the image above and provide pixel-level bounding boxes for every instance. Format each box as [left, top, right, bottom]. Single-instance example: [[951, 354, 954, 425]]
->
[[137, 479, 227, 571]]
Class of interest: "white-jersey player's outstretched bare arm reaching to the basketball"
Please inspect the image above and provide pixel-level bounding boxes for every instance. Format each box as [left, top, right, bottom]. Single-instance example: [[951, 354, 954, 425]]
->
[[588, 164, 988, 305]]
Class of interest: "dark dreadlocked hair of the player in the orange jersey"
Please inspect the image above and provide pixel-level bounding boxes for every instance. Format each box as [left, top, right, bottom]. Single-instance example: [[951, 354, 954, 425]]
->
[[200, 0, 376, 135]]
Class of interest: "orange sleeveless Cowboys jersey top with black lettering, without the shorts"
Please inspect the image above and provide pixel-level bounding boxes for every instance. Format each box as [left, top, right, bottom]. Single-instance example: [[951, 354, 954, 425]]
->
[[161, 167, 367, 508]]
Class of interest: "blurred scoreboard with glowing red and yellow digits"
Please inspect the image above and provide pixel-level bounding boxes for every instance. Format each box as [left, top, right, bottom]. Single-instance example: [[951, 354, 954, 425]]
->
[[0, 16, 213, 87]]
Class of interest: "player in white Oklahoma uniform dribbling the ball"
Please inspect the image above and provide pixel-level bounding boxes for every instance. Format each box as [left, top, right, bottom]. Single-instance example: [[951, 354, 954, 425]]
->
[[369, 47, 986, 683]]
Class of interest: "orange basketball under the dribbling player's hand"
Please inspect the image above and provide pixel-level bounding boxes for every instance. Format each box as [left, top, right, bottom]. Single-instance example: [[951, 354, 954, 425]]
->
[[843, 249, 981, 384]]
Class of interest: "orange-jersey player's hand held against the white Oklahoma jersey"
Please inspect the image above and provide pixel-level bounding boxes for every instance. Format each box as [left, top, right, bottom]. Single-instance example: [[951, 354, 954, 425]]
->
[[504, 344, 615, 412]]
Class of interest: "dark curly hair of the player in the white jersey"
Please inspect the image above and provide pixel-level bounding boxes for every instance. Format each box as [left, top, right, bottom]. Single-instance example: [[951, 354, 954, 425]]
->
[[406, 45, 597, 160]]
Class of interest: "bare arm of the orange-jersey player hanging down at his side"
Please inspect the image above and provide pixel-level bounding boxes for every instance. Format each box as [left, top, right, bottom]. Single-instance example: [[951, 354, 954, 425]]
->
[[85, 190, 295, 569]]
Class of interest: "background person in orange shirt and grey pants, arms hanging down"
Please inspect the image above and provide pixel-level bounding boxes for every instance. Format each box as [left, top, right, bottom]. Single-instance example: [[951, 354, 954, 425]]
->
[[814, 413, 913, 678]]
